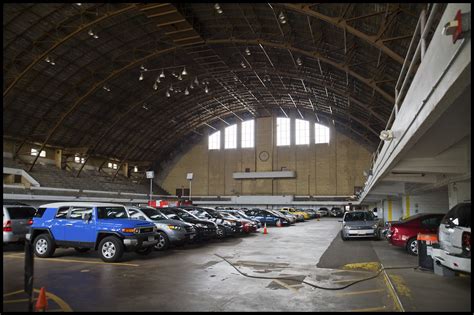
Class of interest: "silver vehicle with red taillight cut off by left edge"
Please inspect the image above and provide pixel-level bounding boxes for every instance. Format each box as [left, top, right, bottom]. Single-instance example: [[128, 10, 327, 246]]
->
[[3, 202, 36, 245]]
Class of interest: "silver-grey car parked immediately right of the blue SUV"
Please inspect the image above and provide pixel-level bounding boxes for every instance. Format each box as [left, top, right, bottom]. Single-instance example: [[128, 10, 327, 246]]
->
[[127, 207, 197, 250]]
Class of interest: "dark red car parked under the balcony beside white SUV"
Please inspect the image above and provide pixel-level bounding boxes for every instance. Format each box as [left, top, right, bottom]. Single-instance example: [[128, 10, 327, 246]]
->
[[387, 213, 445, 256]]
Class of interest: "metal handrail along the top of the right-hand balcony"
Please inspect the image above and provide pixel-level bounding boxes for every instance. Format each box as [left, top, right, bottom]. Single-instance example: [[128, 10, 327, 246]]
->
[[359, 3, 439, 197]]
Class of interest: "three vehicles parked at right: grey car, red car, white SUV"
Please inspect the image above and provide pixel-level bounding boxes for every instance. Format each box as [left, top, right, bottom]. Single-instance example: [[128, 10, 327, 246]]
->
[[340, 203, 471, 273]]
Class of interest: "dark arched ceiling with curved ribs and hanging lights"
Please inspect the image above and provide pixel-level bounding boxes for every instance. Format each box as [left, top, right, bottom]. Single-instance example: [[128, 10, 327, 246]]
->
[[3, 3, 443, 172]]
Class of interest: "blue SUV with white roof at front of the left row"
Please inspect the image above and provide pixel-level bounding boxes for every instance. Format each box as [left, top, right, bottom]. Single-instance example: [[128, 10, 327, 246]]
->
[[27, 202, 158, 262]]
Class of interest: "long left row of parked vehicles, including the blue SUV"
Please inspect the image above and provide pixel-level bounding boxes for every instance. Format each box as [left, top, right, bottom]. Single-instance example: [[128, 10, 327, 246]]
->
[[3, 202, 320, 262]]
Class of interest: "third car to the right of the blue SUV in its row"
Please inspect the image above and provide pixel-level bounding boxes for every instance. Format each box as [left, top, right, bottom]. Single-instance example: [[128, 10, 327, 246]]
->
[[180, 206, 242, 238]]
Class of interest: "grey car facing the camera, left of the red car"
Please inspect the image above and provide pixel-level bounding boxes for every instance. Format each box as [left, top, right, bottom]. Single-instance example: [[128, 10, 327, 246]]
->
[[339, 210, 380, 241]]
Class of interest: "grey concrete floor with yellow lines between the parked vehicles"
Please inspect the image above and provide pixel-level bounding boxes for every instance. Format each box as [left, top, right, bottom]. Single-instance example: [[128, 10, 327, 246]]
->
[[3, 218, 471, 311]]
